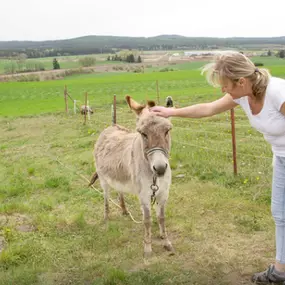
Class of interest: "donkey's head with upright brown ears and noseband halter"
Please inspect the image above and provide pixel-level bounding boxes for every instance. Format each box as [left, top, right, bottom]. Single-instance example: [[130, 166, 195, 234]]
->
[[126, 96, 172, 176]]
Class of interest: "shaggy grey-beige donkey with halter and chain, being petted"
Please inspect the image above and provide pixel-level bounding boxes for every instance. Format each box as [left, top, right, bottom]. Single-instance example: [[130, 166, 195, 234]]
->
[[89, 96, 174, 258]]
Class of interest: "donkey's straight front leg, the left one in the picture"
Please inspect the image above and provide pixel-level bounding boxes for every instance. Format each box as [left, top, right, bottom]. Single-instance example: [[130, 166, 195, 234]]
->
[[141, 199, 152, 258]]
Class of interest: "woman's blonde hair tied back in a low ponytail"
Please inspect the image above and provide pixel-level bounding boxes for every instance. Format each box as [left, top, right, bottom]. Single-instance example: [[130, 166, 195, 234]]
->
[[202, 52, 271, 99]]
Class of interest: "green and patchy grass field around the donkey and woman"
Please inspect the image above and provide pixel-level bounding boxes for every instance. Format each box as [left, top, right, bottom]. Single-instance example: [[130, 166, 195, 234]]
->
[[0, 56, 285, 285]]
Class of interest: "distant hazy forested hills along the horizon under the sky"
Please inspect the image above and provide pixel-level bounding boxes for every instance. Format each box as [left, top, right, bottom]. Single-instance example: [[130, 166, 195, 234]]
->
[[0, 35, 285, 58]]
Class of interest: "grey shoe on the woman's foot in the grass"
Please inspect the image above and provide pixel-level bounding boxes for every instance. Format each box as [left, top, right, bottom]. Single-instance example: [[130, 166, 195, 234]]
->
[[251, 265, 285, 284]]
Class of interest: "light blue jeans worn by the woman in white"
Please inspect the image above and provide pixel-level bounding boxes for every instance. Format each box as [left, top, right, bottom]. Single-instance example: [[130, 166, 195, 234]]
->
[[271, 156, 285, 264]]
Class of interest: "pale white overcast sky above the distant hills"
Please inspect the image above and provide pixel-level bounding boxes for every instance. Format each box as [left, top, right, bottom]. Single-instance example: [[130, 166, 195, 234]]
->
[[0, 0, 285, 41]]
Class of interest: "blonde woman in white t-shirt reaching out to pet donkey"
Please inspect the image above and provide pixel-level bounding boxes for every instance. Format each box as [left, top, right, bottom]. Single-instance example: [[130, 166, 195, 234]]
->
[[151, 53, 285, 284]]
